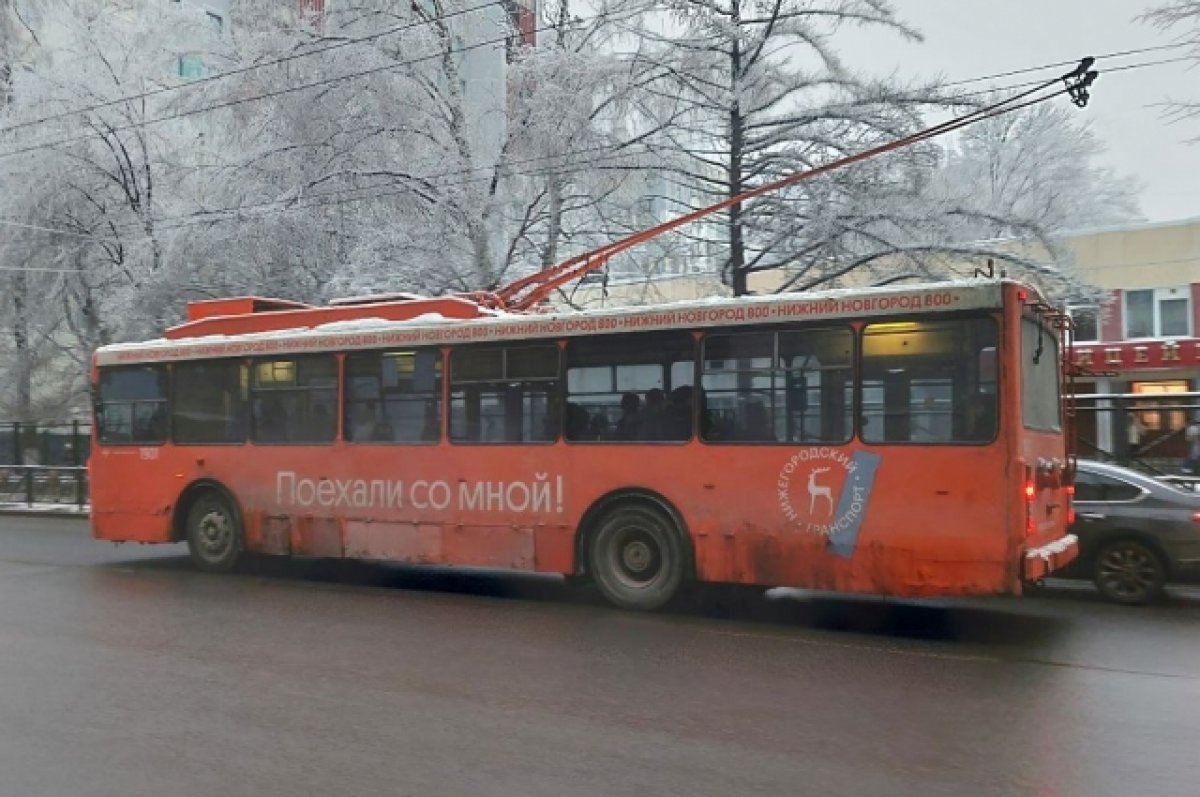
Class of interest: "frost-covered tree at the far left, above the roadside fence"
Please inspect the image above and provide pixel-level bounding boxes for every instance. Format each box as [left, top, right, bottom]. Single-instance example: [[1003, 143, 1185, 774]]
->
[[0, 0, 225, 414]]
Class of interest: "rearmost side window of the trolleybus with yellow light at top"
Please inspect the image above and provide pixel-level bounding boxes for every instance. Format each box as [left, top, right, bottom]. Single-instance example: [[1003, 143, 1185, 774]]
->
[[862, 318, 997, 443]]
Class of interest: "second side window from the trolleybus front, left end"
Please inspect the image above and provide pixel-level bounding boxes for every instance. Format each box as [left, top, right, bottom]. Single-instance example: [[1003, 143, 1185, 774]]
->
[[170, 360, 250, 443]]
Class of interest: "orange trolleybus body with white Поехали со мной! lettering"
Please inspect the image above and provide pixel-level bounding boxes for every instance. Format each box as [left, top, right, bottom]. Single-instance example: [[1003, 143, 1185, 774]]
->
[[90, 280, 1078, 609]]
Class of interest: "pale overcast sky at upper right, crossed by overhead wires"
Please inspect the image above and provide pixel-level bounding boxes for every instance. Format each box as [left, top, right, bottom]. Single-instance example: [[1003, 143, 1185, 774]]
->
[[840, 0, 1200, 221]]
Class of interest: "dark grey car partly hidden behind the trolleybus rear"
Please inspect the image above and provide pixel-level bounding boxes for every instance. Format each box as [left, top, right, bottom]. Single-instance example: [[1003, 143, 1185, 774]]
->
[[1070, 460, 1200, 604]]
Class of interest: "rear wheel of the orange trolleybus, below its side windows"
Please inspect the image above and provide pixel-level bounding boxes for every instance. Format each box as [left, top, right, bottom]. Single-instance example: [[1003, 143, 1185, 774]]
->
[[588, 503, 685, 611]]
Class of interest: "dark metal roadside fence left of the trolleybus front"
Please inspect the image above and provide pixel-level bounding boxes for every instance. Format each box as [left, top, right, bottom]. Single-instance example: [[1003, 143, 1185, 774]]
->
[[0, 421, 91, 509]]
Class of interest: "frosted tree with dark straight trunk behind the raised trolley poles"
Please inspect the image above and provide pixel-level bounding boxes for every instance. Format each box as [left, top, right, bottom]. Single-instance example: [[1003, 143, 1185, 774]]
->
[[628, 0, 955, 294]]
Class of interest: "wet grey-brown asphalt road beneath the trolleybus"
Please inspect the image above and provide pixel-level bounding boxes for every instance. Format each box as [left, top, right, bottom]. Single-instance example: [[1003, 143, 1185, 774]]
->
[[0, 517, 1200, 797]]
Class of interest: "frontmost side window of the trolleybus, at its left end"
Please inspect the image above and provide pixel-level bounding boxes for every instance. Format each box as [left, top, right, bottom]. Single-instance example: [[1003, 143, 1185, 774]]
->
[[96, 366, 167, 443]]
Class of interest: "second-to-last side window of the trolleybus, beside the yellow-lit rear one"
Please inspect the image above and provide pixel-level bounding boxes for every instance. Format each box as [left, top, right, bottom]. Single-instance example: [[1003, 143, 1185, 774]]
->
[[702, 329, 854, 443]]
